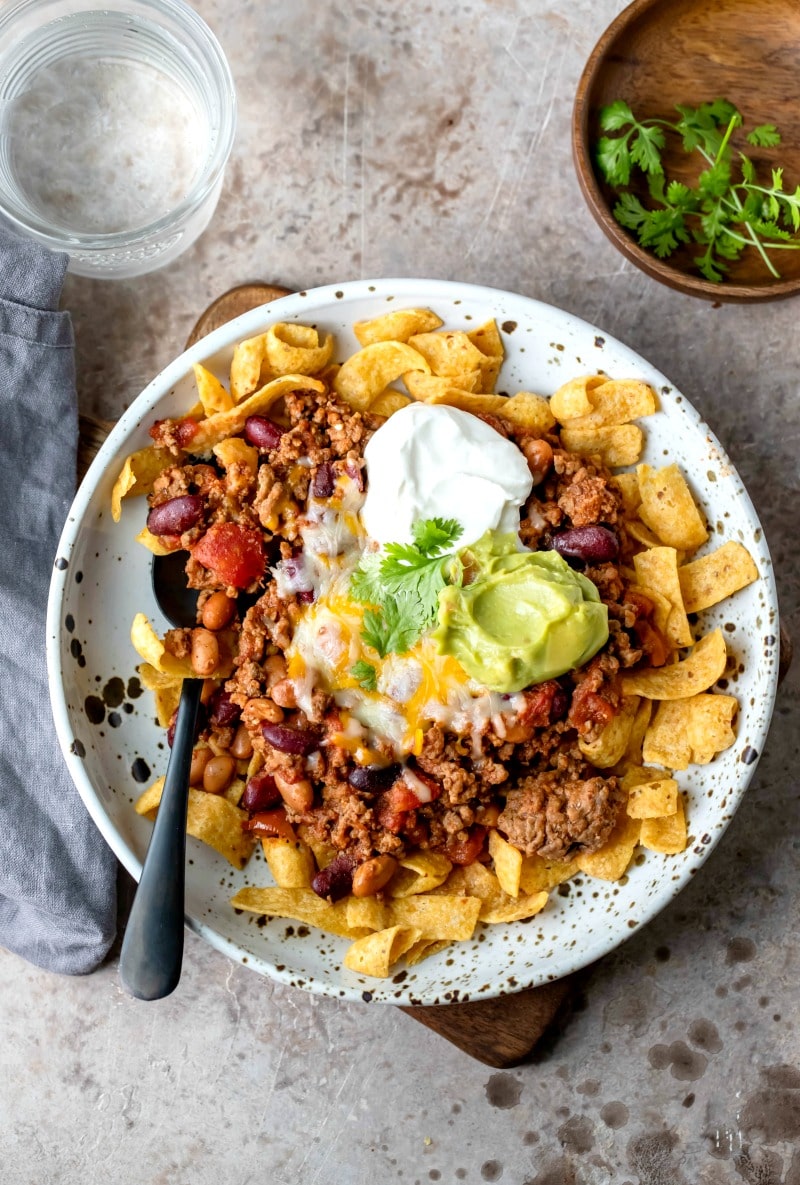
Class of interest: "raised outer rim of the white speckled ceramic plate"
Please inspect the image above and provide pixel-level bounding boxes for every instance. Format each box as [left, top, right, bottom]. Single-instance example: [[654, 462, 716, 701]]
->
[[46, 278, 777, 1005]]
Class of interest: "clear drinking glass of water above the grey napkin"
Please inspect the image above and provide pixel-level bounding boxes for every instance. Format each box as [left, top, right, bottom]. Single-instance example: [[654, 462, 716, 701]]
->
[[0, 0, 236, 278]]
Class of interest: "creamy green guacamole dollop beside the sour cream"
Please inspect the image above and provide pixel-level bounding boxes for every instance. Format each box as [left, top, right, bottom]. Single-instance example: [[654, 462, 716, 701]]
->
[[433, 531, 608, 693]]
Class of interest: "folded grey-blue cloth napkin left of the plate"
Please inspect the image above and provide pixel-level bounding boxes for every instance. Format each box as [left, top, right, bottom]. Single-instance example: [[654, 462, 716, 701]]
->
[[0, 224, 116, 975]]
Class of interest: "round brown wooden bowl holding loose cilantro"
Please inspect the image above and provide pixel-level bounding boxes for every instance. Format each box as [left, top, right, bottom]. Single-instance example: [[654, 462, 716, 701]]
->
[[572, 0, 800, 301]]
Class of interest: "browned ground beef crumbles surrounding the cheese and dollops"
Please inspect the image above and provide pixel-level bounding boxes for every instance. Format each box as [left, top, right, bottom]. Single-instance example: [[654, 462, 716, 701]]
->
[[149, 391, 666, 876]]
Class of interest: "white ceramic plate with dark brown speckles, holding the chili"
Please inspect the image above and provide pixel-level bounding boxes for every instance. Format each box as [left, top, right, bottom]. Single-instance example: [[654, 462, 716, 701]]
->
[[47, 280, 779, 1004]]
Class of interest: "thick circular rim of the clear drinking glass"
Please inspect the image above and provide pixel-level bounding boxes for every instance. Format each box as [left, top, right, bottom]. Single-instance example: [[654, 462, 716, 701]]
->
[[0, 0, 237, 252]]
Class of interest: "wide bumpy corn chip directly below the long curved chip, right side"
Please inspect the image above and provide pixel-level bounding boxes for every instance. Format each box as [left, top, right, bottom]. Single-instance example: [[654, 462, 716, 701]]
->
[[642, 694, 738, 769]]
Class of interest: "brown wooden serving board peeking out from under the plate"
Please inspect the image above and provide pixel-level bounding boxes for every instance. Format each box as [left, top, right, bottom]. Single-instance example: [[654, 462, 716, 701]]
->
[[78, 284, 792, 1068]]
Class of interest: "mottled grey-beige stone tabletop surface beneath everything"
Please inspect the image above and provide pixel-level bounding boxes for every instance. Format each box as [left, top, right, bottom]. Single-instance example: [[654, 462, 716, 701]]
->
[[0, 0, 800, 1185]]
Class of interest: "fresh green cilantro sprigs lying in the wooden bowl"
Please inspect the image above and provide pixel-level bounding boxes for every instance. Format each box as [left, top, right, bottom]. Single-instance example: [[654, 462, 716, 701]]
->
[[596, 98, 800, 283]]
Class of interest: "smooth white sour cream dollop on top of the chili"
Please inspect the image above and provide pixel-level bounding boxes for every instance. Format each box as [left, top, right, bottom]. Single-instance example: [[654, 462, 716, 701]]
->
[[361, 403, 533, 547]]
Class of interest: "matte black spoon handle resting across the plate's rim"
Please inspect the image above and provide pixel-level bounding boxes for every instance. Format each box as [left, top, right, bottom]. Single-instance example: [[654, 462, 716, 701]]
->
[[120, 679, 203, 1000]]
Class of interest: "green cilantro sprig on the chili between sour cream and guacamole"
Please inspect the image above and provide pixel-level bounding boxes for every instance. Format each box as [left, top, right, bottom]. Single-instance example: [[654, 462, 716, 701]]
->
[[350, 518, 463, 663]]
